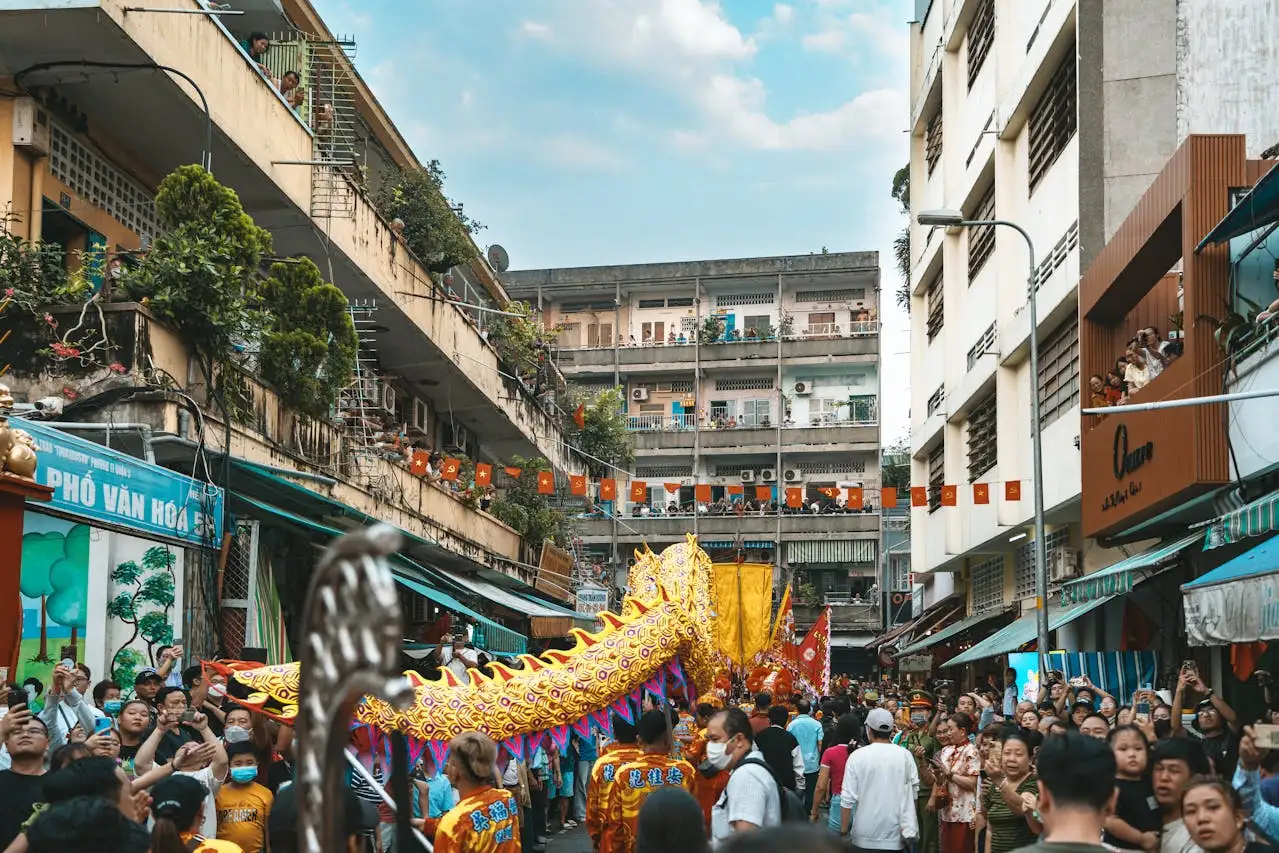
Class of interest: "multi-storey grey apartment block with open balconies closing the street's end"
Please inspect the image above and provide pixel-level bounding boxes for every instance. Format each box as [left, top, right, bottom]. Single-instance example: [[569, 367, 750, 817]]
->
[[503, 252, 883, 669]]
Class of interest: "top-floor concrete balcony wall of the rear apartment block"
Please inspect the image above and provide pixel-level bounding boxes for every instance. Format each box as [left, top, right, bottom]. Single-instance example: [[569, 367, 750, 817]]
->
[[556, 321, 880, 379]]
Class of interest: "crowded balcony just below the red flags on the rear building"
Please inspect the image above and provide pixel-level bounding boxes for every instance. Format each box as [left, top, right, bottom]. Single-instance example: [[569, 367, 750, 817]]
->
[[573, 513, 880, 546]]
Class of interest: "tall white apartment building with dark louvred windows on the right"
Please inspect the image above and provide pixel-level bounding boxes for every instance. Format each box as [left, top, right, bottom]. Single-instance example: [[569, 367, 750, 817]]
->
[[911, 0, 1275, 670]]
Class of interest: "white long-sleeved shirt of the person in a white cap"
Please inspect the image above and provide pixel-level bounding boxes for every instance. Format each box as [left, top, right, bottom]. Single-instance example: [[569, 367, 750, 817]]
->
[[839, 742, 920, 850]]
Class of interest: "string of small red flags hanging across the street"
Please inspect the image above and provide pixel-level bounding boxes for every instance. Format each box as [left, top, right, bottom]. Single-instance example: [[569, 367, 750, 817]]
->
[[409, 450, 1022, 509]]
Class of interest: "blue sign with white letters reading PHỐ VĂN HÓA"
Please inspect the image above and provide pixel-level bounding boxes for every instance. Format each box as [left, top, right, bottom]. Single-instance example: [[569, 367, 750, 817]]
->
[[18, 418, 223, 546]]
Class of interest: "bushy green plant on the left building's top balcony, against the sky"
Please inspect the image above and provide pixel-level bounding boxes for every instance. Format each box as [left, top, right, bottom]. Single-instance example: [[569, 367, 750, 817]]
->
[[373, 160, 483, 272]]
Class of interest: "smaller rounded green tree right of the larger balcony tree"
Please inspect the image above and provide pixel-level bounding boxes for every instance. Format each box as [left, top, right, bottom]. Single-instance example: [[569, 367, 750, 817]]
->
[[260, 258, 359, 418]]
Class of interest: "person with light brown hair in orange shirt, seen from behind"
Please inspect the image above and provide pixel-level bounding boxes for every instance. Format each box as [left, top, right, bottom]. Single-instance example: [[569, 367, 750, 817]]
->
[[435, 732, 519, 853]]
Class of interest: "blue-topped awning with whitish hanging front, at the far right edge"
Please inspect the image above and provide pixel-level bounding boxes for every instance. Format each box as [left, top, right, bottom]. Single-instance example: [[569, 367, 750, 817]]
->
[[1182, 537, 1279, 646]]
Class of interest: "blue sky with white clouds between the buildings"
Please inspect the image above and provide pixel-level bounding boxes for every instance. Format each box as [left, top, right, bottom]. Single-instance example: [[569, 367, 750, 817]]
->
[[313, 0, 913, 444]]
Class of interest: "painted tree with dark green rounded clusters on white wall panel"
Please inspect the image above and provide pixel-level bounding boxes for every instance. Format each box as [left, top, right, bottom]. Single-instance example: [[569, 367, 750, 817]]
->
[[106, 546, 178, 691]]
